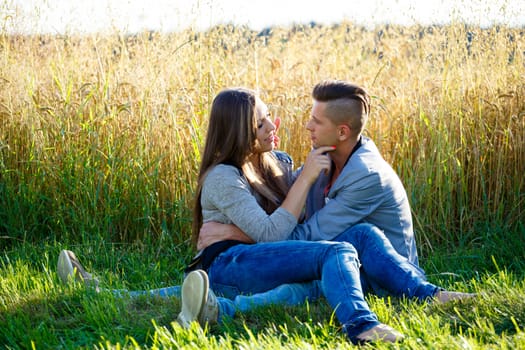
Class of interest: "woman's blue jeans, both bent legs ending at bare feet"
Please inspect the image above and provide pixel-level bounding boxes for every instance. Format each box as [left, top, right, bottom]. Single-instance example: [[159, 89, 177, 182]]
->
[[208, 224, 438, 340]]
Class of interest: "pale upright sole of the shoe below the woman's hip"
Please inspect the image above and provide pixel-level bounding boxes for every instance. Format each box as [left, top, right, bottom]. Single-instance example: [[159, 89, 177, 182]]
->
[[177, 270, 209, 328]]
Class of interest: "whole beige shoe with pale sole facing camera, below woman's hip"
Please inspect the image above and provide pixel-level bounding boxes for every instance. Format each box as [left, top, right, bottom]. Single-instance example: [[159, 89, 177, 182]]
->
[[177, 270, 219, 328]]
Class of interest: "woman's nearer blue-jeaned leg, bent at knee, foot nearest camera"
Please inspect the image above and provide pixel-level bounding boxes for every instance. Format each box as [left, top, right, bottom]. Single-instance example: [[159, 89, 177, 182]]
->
[[208, 241, 380, 340]]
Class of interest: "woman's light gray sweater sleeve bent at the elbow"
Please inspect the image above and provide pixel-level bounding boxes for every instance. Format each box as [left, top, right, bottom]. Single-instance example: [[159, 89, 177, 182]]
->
[[201, 164, 297, 242]]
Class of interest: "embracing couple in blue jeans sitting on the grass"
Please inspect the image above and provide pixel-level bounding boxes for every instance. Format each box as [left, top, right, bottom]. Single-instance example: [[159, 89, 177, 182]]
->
[[58, 80, 473, 343]]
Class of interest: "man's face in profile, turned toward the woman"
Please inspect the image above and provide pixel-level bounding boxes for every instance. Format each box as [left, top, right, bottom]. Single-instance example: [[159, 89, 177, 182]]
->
[[306, 100, 339, 148]]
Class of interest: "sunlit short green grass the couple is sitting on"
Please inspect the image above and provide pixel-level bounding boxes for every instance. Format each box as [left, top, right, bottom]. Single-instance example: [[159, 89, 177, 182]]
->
[[0, 241, 525, 349]]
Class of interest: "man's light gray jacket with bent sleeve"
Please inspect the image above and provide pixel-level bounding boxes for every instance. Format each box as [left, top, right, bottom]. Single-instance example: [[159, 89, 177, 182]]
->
[[289, 137, 418, 265]]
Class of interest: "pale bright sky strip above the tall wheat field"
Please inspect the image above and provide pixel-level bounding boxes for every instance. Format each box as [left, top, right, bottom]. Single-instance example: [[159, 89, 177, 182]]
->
[[0, 0, 525, 34]]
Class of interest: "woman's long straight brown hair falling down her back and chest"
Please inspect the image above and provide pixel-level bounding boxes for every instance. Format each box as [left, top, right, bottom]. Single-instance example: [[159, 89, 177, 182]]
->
[[192, 88, 288, 243]]
